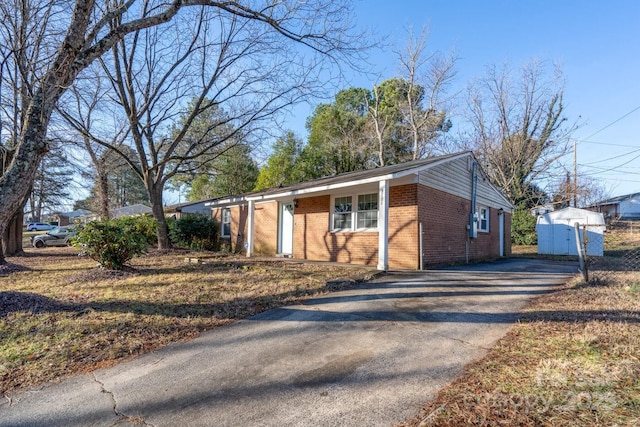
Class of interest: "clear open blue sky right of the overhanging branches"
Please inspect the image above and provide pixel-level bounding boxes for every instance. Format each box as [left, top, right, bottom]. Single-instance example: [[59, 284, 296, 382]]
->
[[289, 0, 640, 200]]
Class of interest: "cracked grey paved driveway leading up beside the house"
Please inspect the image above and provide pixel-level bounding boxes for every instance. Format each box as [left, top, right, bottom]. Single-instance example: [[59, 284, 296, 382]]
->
[[0, 260, 577, 427]]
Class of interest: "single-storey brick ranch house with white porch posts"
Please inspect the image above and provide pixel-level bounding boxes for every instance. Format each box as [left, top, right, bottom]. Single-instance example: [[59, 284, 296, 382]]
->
[[208, 151, 513, 270]]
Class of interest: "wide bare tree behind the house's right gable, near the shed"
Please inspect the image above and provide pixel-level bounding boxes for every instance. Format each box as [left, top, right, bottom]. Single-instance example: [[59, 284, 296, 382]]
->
[[468, 61, 576, 208]]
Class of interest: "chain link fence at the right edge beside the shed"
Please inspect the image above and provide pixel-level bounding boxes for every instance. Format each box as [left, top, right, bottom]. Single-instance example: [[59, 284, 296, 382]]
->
[[580, 220, 640, 282]]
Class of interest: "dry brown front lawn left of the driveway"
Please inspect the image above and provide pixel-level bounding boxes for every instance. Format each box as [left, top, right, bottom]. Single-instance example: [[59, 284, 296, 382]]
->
[[0, 246, 373, 395]]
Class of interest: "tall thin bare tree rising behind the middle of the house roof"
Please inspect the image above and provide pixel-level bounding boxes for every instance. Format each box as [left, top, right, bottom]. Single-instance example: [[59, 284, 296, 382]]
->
[[396, 28, 457, 160]]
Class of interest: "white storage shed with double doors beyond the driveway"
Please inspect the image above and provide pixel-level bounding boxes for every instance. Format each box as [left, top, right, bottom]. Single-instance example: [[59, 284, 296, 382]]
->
[[536, 208, 606, 256]]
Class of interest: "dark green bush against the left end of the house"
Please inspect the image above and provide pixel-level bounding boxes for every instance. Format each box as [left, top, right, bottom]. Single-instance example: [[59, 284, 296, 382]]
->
[[168, 215, 218, 251]]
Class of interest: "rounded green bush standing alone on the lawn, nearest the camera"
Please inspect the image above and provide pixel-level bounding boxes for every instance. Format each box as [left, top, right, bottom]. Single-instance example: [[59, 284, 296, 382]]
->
[[74, 217, 155, 270]]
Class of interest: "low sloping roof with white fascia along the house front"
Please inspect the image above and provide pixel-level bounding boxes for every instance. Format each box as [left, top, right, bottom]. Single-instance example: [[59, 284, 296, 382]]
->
[[206, 151, 472, 209]]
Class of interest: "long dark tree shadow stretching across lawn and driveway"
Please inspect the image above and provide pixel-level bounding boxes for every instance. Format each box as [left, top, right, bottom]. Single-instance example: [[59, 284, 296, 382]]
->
[[0, 291, 640, 323]]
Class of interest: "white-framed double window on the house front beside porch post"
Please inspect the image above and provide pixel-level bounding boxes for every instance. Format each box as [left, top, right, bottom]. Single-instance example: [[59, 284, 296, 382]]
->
[[331, 193, 378, 231]]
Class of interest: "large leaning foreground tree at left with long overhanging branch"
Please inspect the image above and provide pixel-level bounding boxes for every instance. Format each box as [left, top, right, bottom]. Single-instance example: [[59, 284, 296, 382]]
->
[[0, 0, 365, 263]]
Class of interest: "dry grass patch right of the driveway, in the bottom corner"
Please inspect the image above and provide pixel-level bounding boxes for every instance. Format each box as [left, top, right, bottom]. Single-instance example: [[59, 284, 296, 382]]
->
[[402, 271, 640, 426]]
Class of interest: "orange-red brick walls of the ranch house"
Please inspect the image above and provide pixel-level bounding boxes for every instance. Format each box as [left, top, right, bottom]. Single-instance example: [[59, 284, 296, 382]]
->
[[212, 184, 511, 269]]
